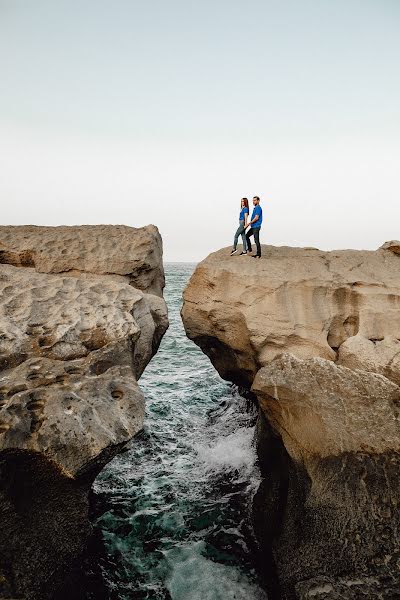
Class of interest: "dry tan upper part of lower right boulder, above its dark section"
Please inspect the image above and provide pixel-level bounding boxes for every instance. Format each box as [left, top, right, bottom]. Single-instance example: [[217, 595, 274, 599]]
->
[[252, 354, 400, 464]]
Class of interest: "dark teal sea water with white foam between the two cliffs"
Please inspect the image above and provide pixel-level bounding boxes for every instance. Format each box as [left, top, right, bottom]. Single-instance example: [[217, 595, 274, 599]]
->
[[90, 264, 266, 600]]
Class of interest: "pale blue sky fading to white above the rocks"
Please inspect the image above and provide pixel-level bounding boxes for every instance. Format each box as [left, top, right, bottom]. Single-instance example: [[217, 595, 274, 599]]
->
[[0, 0, 400, 261]]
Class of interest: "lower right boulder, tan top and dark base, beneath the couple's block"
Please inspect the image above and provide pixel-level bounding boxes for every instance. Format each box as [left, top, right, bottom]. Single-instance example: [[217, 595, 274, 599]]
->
[[252, 354, 400, 598]]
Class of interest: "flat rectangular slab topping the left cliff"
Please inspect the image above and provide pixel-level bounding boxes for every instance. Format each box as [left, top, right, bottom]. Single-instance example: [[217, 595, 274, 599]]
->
[[0, 225, 164, 296]]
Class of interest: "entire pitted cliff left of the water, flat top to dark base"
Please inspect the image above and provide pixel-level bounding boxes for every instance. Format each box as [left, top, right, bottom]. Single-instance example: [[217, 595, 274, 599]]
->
[[0, 226, 168, 599]]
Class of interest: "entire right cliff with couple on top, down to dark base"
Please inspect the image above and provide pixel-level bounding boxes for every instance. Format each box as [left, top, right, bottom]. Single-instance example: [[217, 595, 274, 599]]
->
[[182, 241, 400, 600]]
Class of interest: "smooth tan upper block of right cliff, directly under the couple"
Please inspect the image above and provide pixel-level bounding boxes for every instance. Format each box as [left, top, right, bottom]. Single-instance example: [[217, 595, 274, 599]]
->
[[182, 246, 400, 384]]
